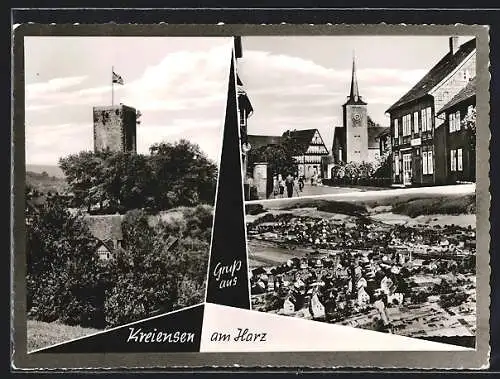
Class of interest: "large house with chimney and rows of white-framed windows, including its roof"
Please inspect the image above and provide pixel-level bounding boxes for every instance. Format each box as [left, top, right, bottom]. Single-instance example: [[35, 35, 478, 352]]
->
[[387, 37, 476, 186]]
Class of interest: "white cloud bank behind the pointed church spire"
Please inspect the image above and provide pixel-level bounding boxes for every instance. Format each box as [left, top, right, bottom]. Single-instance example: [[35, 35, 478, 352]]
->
[[238, 50, 426, 145]]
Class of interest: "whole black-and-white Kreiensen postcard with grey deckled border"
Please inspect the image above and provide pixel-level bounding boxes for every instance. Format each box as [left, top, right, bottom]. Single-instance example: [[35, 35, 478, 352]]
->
[[11, 20, 490, 371]]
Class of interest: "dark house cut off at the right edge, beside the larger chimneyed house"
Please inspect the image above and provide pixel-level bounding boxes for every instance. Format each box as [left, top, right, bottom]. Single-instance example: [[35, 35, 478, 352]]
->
[[435, 78, 476, 184]]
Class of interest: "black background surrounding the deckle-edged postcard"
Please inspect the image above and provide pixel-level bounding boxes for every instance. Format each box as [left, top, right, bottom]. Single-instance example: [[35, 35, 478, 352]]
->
[[7, 4, 500, 378]]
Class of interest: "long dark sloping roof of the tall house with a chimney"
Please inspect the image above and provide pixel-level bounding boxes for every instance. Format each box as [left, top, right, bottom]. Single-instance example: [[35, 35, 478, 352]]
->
[[386, 38, 476, 112]]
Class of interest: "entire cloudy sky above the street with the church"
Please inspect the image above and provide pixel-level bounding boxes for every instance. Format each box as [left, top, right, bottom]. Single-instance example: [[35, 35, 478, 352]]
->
[[239, 36, 472, 149]]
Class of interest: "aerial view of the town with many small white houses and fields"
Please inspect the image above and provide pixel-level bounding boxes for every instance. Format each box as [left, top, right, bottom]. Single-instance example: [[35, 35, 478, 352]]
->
[[246, 189, 476, 347]]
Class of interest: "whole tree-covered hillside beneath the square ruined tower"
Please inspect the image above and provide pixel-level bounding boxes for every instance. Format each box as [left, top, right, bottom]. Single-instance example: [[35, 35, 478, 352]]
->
[[25, 140, 217, 344]]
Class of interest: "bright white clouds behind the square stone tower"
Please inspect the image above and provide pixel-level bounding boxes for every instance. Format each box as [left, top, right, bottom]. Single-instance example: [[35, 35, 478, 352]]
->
[[25, 38, 232, 164]]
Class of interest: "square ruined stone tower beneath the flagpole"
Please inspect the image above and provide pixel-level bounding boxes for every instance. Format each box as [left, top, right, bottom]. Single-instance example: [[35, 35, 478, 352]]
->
[[94, 104, 137, 153]]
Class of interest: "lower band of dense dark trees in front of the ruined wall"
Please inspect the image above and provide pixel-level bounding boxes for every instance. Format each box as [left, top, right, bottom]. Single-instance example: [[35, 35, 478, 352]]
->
[[26, 191, 213, 328]]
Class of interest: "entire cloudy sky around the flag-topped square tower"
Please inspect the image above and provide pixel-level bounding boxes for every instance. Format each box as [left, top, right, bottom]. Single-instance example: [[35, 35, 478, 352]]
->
[[25, 37, 232, 165]]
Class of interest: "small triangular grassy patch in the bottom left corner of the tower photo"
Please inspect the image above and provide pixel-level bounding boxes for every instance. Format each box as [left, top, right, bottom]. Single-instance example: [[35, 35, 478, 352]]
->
[[27, 320, 99, 352]]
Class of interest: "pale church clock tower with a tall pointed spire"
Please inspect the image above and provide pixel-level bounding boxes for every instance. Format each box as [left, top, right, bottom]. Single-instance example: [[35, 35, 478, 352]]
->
[[342, 58, 368, 162]]
